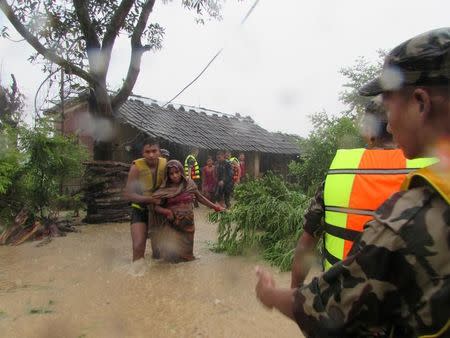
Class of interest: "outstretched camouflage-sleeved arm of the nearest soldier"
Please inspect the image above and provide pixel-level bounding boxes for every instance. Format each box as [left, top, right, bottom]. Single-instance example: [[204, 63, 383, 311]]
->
[[257, 221, 402, 337]]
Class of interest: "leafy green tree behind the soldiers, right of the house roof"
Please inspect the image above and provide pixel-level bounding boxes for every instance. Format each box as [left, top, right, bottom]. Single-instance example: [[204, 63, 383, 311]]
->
[[289, 50, 386, 195]]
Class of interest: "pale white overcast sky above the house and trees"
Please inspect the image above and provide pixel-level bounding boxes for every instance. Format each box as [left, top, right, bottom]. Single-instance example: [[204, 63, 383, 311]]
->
[[0, 0, 450, 136]]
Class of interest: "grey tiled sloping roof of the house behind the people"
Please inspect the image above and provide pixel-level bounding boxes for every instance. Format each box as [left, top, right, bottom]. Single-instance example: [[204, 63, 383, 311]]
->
[[118, 96, 300, 155]]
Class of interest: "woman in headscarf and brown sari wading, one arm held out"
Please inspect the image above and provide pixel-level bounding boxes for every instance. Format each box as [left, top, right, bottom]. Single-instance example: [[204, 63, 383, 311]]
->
[[152, 160, 224, 263]]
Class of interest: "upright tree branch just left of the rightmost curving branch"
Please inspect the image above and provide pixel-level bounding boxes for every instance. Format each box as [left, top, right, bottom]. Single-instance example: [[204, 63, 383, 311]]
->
[[102, 0, 134, 72]]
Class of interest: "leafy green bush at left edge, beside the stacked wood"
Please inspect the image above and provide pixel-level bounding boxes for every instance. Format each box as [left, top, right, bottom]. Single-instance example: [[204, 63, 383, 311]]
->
[[0, 119, 87, 224]]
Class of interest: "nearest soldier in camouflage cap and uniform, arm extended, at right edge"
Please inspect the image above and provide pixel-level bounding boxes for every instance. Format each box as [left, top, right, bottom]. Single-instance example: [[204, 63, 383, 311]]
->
[[256, 28, 450, 337]]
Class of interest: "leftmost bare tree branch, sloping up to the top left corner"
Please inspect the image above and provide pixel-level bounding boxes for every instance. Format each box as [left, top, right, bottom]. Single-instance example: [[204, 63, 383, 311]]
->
[[0, 0, 96, 84]]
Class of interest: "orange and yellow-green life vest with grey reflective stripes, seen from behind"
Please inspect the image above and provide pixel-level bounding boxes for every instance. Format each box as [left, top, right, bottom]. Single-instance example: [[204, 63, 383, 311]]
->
[[324, 149, 437, 269]]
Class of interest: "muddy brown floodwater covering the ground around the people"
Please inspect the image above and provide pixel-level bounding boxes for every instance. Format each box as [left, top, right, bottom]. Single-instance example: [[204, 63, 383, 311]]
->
[[0, 208, 302, 338]]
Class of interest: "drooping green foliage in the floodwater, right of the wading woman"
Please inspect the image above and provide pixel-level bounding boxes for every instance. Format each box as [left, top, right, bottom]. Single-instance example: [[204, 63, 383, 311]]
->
[[210, 173, 308, 271]]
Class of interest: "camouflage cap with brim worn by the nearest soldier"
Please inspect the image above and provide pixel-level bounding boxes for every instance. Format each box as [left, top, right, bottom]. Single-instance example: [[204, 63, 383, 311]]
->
[[359, 27, 450, 96]]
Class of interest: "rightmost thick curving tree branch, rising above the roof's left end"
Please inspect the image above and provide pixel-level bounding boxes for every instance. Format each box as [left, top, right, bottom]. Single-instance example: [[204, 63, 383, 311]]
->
[[112, 0, 155, 112]]
